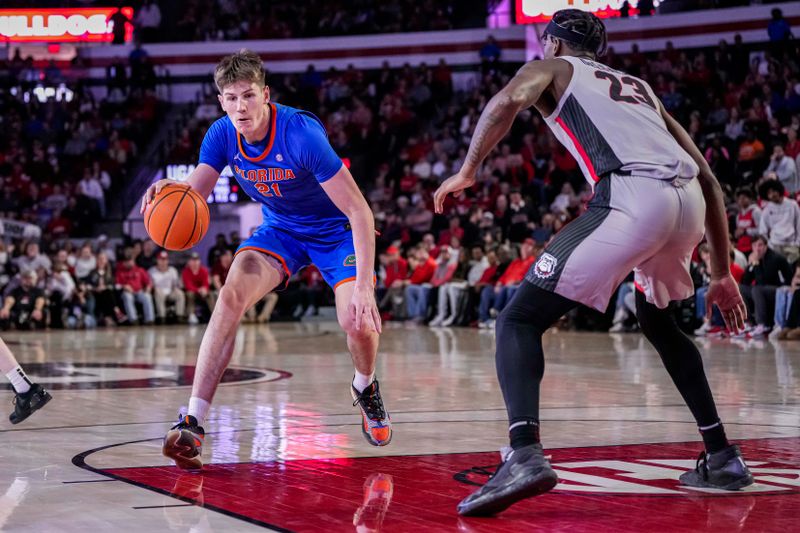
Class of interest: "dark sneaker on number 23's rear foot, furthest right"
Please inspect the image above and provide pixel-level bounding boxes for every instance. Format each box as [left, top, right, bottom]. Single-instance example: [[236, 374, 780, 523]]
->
[[680, 445, 753, 490]]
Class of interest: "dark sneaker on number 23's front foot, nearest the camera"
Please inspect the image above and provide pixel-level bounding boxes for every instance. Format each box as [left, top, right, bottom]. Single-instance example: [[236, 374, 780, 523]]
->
[[458, 444, 558, 516]]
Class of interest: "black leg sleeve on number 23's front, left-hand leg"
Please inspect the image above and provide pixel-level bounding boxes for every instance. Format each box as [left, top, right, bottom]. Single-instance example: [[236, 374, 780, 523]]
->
[[495, 281, 577, 448]]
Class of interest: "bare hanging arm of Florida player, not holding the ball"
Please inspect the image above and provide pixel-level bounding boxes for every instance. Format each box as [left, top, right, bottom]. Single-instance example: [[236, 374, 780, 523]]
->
[[321, 165, 381, 333]]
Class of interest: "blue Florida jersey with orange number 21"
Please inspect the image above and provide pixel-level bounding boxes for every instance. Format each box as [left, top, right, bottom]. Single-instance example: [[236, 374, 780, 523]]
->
[[200, 103, 347, 237]]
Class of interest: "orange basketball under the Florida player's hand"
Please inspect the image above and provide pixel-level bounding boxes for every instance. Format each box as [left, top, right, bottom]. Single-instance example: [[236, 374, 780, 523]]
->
[[144, 183, 210, 251]]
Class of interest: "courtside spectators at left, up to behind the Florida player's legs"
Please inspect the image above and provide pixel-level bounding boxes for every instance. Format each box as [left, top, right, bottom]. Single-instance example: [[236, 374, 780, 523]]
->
[[0, 232, 330, 330]]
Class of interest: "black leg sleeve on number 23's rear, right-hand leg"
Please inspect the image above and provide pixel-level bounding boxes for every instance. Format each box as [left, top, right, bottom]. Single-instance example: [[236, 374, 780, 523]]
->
[[636, 290, 728, 452]]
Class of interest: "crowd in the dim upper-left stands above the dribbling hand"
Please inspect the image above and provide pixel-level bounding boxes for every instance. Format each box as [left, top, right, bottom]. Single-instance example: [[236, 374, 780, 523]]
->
[[0, 49, 162, 238]]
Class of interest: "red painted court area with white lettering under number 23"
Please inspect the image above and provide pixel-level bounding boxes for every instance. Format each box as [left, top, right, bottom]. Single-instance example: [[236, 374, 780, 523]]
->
[[98, 438, 800, 532]]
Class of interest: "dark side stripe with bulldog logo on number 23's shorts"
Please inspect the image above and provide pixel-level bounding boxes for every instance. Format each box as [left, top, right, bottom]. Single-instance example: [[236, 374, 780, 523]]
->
[[525, 180, 613, 292]]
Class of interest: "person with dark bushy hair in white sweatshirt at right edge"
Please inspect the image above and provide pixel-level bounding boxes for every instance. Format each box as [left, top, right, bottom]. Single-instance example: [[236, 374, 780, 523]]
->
[[758, 180, 800, 263]]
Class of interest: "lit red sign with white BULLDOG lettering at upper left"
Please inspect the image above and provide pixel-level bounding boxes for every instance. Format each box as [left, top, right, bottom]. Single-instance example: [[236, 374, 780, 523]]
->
[[0, 7, 133, 43]]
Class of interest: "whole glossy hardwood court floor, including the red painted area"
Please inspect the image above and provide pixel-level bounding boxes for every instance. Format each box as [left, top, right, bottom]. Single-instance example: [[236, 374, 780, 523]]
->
[[0, 323, 800, 532]]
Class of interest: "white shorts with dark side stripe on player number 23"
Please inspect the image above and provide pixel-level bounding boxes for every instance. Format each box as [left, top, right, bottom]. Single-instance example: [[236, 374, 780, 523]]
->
[[525, 174, 706, 312]]
